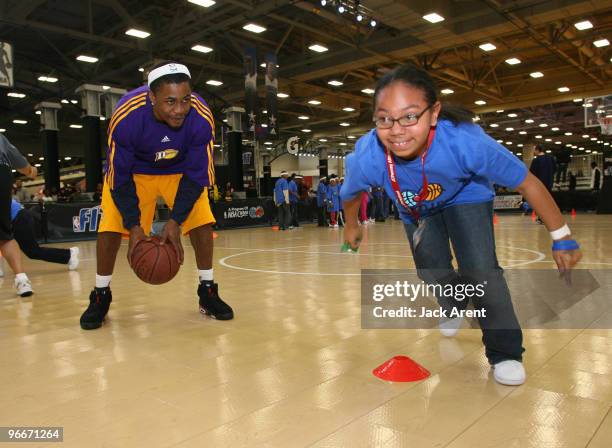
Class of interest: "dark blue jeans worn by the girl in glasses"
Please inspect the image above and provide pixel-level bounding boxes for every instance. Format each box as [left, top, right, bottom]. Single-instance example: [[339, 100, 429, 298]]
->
[[404, 202, 525, 364]]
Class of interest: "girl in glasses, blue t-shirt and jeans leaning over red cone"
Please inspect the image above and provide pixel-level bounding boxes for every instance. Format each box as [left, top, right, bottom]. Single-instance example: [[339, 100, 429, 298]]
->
[[341, 65, 581, 385]]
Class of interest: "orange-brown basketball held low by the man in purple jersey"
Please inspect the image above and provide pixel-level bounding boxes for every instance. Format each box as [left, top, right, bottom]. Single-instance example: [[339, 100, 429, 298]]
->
[[130, 236, 180, 285]]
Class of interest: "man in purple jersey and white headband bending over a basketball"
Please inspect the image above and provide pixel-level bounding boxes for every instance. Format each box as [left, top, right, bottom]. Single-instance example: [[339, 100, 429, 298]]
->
[[81, 62, 234, 330]]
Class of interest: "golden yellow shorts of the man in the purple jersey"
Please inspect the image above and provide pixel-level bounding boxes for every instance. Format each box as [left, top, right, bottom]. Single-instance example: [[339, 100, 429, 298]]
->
[[98, 174, 215, 235]]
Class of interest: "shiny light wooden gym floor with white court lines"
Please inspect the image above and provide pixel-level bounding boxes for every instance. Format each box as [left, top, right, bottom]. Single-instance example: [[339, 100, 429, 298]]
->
[[0, 215, 612, 448]]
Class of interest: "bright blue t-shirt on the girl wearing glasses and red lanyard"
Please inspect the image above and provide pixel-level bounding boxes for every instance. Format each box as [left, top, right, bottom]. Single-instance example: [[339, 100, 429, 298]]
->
[[340, 120, 527, 223]]
